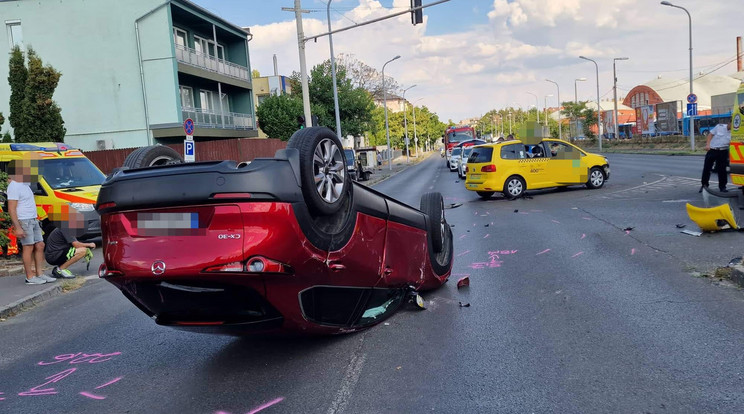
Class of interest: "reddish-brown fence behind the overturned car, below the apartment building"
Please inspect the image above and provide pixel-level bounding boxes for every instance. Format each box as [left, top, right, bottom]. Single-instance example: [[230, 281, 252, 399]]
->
[[85, 138, 287, 175]]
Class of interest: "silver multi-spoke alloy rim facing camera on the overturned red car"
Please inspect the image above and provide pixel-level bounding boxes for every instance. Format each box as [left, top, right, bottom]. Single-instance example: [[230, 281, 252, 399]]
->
[[313, 138, 346, 204]]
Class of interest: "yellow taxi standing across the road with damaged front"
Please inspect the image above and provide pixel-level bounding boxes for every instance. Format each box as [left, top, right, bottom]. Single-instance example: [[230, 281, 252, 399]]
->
[[465, 139, 610, 199]]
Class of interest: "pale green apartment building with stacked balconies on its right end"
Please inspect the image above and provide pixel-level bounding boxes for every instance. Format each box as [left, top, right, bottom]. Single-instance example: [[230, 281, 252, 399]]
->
[[0, 0, 258, 150]]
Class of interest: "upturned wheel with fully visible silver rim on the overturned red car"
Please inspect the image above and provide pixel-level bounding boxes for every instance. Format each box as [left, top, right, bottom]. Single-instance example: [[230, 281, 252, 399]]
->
[[287, 127, 352, 215]]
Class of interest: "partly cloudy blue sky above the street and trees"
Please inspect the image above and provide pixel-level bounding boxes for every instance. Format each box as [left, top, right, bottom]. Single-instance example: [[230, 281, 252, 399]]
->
[[192, 0, 744, 121]]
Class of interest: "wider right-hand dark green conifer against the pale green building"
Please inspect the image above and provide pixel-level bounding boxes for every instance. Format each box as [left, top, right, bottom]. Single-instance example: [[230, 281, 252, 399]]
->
[[15, 48, 67, 142]]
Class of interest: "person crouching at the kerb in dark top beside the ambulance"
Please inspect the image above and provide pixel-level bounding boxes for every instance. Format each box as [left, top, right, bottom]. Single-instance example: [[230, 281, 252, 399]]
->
[[44, 210, 96, 279]]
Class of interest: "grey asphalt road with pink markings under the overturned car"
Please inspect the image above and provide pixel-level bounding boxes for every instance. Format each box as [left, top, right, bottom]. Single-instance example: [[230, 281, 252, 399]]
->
[[0, 154, 744, 414]]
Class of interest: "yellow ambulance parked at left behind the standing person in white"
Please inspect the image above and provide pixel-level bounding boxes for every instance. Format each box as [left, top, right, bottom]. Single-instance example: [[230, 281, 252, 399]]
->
[[0, 142, 106, 239]]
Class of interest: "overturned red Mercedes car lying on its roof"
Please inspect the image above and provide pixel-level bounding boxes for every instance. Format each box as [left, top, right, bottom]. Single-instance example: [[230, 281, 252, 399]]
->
[[96, 127, 453, 334]]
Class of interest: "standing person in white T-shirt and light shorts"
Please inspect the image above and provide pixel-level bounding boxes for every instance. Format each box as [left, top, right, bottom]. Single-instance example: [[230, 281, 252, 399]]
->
[[7, 159, 57, 285]]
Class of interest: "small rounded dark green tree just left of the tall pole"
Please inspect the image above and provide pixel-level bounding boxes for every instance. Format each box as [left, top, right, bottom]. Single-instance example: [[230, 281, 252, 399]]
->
[[256, 94, 303, 141]]
